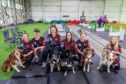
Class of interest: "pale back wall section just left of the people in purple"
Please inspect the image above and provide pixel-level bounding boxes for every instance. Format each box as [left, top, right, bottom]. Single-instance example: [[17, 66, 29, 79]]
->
[[79, 0, 104, 20]]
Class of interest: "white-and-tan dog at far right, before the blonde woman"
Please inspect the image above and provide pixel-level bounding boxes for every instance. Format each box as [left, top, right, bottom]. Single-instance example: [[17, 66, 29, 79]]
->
[[97, 49, 117, 73]]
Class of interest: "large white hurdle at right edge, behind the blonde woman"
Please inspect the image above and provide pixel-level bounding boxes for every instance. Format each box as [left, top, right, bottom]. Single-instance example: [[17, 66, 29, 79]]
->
[[109, 27, 125, 41]]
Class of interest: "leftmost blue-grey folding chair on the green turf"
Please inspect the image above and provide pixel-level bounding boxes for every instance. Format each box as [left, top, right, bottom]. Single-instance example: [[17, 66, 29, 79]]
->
[[2, 30, 15, 47]]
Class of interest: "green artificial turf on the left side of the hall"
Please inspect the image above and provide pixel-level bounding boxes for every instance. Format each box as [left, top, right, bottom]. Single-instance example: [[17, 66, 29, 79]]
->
[[0, 23, 49, 80]]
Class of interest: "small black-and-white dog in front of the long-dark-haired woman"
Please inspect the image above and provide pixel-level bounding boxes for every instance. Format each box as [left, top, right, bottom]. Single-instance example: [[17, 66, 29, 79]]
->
[[64, 51, 76, 76]]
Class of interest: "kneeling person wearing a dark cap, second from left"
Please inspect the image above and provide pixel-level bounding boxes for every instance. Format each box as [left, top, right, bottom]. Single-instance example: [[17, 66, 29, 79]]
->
[[31, 28, 46, 66]]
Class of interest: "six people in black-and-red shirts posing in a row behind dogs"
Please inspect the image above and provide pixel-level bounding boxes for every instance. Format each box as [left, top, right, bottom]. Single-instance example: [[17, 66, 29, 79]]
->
[[21, 26, 121, 71]]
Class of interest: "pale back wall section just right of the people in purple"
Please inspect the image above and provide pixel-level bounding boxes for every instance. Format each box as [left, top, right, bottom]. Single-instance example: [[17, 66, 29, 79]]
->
[[104, 0, 123, 21]]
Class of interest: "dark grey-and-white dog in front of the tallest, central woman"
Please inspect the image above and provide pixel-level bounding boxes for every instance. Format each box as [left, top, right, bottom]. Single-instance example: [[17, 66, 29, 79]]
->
[[50, 49, 60, 72]]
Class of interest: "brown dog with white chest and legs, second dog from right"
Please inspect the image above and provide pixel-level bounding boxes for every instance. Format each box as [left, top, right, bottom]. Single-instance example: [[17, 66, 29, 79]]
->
[[83, 48, 94, 72]]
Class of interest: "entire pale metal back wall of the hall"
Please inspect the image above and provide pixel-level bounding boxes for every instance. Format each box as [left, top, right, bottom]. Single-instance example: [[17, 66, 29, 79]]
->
[[32, 0, 126, 21]]
